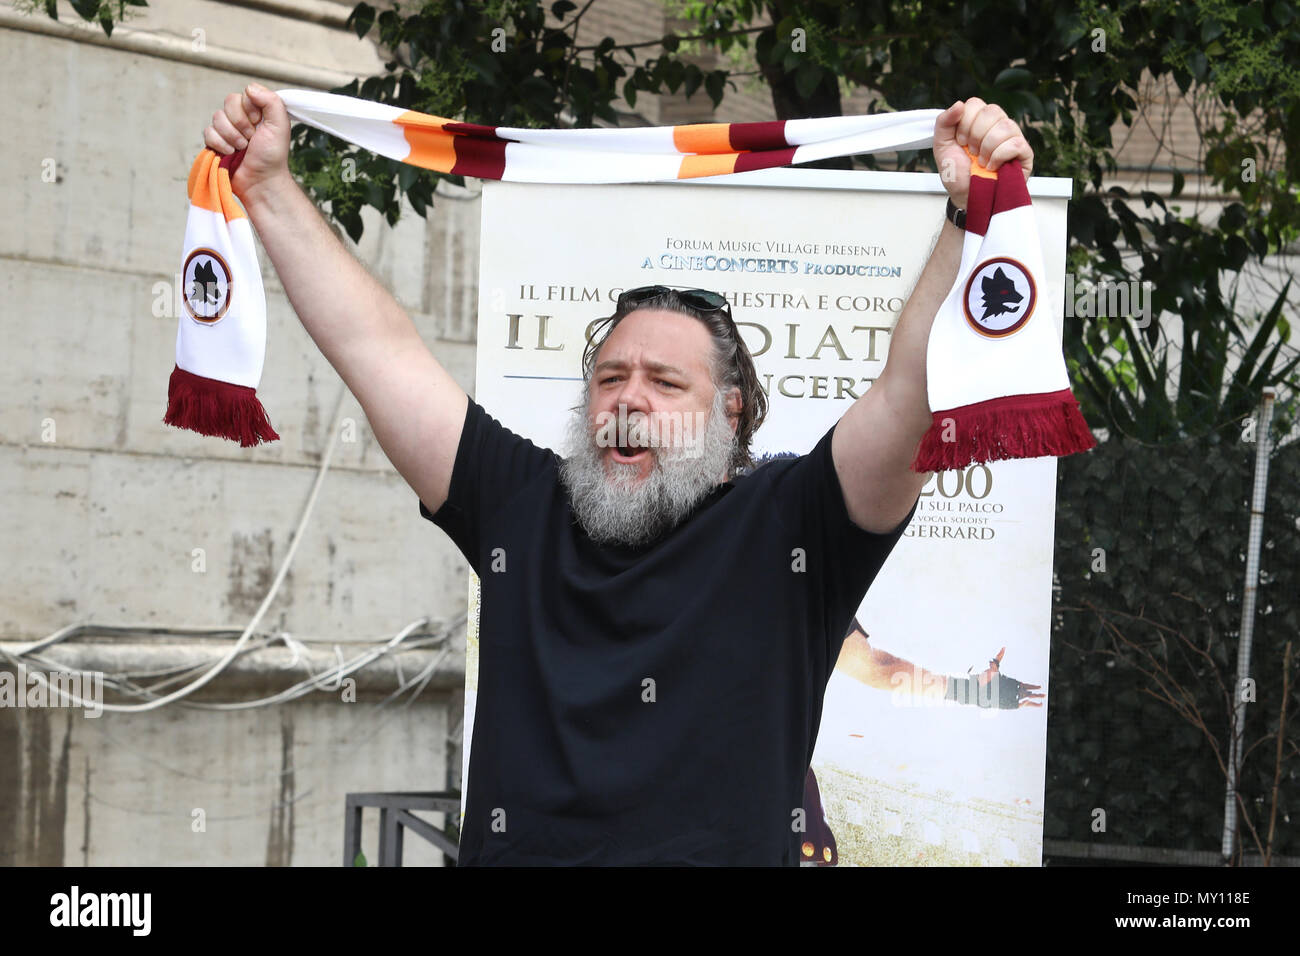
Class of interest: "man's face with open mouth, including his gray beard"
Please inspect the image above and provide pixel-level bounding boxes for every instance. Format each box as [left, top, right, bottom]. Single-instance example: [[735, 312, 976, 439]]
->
[[562, 310, 740, 546]]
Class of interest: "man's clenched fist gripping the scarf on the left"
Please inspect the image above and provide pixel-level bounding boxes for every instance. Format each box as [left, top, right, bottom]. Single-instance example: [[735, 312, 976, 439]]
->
[[203, 83, 293, 199]]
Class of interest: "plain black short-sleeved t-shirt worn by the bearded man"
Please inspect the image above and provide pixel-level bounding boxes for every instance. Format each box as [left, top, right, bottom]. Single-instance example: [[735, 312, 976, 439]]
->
[[420, 399, 917, 866]]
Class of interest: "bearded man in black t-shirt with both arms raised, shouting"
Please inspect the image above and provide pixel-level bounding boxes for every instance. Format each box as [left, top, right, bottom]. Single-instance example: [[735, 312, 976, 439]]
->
[[204, 86, 1032, 866]]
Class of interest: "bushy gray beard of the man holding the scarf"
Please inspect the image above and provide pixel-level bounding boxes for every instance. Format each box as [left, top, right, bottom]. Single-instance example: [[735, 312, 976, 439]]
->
[[560, 389, 736, 548]]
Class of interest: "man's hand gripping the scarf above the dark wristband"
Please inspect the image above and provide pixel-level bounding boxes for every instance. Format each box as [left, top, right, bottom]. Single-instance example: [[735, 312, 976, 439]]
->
[[935, 96, 1034, 209]]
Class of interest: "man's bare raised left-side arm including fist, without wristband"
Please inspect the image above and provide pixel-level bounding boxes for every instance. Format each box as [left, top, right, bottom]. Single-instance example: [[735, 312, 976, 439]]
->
[[203, 83, 469, 511]]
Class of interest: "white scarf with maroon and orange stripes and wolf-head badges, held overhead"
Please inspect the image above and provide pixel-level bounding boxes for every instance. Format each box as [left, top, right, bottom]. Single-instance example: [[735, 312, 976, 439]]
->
[[163, 90, 1096, 472]]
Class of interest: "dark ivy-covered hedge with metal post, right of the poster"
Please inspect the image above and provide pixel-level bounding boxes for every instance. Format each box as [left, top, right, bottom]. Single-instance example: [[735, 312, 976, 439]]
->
[[1044, 428, 1300, 855]]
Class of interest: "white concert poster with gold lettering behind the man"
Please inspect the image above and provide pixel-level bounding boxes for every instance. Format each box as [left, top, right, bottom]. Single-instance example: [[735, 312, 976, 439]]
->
[[463, 169, 1070, 866]]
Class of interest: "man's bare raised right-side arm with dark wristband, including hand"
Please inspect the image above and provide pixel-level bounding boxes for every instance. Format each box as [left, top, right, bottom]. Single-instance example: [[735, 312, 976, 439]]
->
[[831, 98, 1034, 533]]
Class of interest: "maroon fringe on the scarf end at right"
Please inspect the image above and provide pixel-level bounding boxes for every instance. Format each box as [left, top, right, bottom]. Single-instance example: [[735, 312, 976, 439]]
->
[[911, 389, 1097, 473]]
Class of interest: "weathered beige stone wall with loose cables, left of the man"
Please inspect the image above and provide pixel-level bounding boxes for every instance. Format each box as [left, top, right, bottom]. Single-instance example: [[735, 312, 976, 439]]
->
[[0, 0, 478, 865]]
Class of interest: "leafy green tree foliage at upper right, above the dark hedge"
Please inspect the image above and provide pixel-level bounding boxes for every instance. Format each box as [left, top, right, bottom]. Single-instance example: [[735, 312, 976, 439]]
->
[[677, 0, 1300, 441]]
